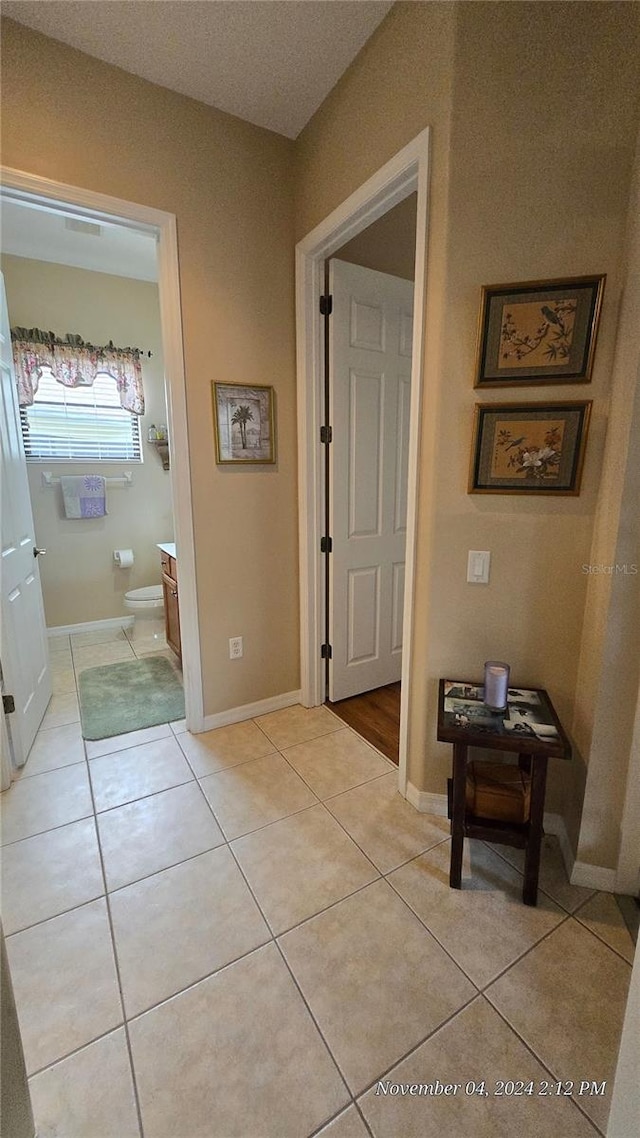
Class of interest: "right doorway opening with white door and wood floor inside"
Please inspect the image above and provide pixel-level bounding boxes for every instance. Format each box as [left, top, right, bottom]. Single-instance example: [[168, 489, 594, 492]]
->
[[326, 199, 417, 766]]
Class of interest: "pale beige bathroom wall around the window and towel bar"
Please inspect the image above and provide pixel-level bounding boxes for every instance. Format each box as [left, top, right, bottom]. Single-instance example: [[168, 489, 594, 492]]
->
[[2, 256, 173, 628]]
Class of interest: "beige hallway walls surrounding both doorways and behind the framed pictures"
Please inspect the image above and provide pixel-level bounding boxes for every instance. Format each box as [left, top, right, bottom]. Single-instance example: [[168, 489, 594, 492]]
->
[[3, 2, 640, 855]]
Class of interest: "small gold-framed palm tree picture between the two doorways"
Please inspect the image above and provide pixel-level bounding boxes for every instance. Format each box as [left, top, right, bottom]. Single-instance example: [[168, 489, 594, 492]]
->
[[212, 382, 276, 463]]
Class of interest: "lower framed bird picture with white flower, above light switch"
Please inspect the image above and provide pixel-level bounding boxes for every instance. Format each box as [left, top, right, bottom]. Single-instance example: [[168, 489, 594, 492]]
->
[[469, 401, 591, 495]]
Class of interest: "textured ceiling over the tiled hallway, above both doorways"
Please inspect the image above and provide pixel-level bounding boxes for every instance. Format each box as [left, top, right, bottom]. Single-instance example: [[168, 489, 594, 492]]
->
[[2, 0, 392, 138]]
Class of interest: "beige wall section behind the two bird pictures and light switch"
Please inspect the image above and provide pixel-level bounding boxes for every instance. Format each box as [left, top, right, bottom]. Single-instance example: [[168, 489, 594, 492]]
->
[[428, 3, 640, 809]]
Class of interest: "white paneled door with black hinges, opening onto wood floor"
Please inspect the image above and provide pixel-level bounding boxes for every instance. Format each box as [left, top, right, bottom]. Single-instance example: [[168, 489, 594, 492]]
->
[[329, 259, 413, 701]]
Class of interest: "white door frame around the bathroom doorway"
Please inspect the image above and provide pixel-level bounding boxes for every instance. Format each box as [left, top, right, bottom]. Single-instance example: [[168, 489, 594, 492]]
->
[[0, 166, 204, 732]]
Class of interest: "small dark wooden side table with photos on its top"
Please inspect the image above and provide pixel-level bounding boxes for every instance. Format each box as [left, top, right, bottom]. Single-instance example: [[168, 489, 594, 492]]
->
[[437, 679, 571, 905]]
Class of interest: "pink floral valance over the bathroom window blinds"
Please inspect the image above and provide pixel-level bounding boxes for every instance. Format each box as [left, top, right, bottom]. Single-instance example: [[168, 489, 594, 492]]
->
[[11, 328, 145, 415]]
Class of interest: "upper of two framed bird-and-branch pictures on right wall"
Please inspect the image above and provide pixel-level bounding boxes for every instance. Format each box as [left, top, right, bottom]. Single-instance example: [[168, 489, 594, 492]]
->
[[475, 275, 606, 387]]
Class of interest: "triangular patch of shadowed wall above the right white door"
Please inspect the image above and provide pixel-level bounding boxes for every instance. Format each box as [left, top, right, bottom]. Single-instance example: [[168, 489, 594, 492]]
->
[[334, 193, 418, 281]]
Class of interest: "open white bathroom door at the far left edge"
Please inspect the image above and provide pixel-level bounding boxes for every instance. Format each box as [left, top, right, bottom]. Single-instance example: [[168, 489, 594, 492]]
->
[[0, 274, 51, 766]]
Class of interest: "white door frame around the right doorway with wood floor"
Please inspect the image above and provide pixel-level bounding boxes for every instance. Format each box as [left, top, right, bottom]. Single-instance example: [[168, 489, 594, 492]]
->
[[296, 127, 430, 794]]
